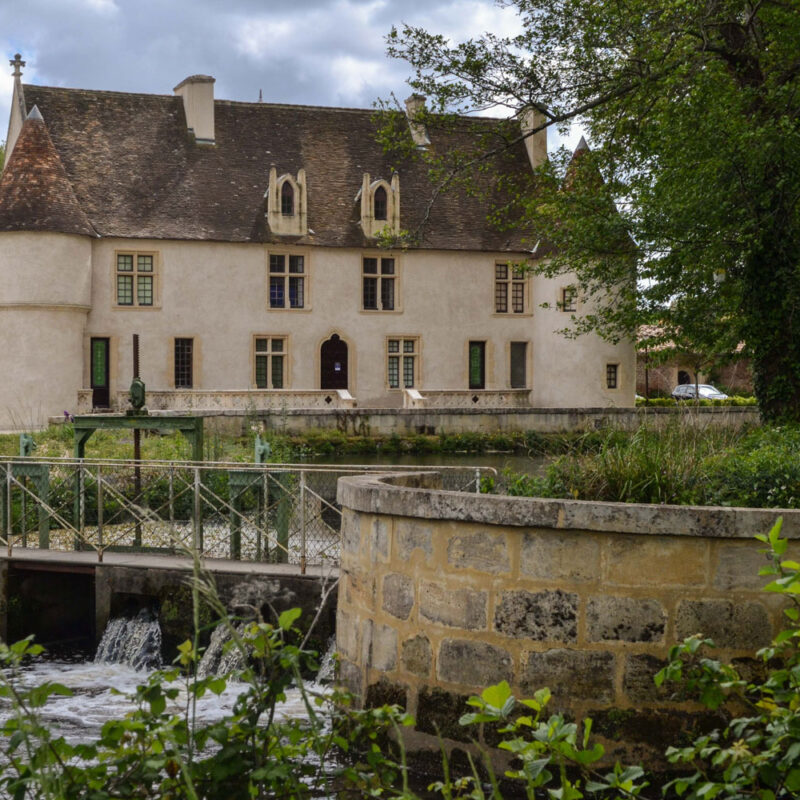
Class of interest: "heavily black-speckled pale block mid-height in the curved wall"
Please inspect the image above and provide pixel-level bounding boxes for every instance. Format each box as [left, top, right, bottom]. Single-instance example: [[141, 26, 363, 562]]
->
[[494, 589, 578, 642]]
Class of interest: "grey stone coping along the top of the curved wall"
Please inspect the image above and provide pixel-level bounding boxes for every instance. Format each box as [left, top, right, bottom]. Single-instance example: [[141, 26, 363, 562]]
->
[[337, 471, 800, 539]]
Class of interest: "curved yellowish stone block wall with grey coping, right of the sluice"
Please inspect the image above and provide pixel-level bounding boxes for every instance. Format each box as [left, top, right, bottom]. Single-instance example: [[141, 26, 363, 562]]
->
[[337, 473, 800, 767]]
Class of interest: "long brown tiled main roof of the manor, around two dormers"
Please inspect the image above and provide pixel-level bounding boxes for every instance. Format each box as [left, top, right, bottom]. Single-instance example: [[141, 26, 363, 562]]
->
[[17, 85, 531, 251]]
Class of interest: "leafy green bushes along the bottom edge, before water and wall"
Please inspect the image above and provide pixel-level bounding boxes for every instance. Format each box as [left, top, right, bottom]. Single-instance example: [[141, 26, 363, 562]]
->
[[0, 520, 800, 800]]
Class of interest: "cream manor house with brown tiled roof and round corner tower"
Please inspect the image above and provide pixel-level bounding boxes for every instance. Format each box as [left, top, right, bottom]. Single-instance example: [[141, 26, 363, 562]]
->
[[0, 56, 635, 429]]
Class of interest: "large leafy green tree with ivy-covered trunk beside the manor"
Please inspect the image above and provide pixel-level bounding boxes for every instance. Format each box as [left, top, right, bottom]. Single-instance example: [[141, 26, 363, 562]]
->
[[388, 0, 800, 420]]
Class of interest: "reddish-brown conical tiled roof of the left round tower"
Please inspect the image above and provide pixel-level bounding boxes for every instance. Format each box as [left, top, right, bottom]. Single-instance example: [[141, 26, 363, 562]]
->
[[0, 107, 95, 236]]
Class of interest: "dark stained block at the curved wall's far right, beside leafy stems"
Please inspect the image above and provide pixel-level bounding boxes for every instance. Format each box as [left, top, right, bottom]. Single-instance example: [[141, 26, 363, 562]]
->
[[675, 600, 772, 650]]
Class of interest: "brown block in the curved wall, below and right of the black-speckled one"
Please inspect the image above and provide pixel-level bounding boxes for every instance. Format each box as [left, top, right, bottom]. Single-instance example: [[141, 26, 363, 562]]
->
[[520, 648, 614, 703]]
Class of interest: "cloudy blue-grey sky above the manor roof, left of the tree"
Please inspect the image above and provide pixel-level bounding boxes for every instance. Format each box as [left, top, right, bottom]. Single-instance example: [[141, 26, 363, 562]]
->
[[0, 0, 576, 149]]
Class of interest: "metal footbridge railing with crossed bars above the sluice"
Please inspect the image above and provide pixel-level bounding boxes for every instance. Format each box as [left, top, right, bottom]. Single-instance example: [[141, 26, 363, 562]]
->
[[0, 458, 496, 571]]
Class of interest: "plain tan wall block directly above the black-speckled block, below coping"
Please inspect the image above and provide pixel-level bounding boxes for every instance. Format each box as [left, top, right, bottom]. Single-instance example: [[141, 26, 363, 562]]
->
[[520, 531, 600, 582]]
